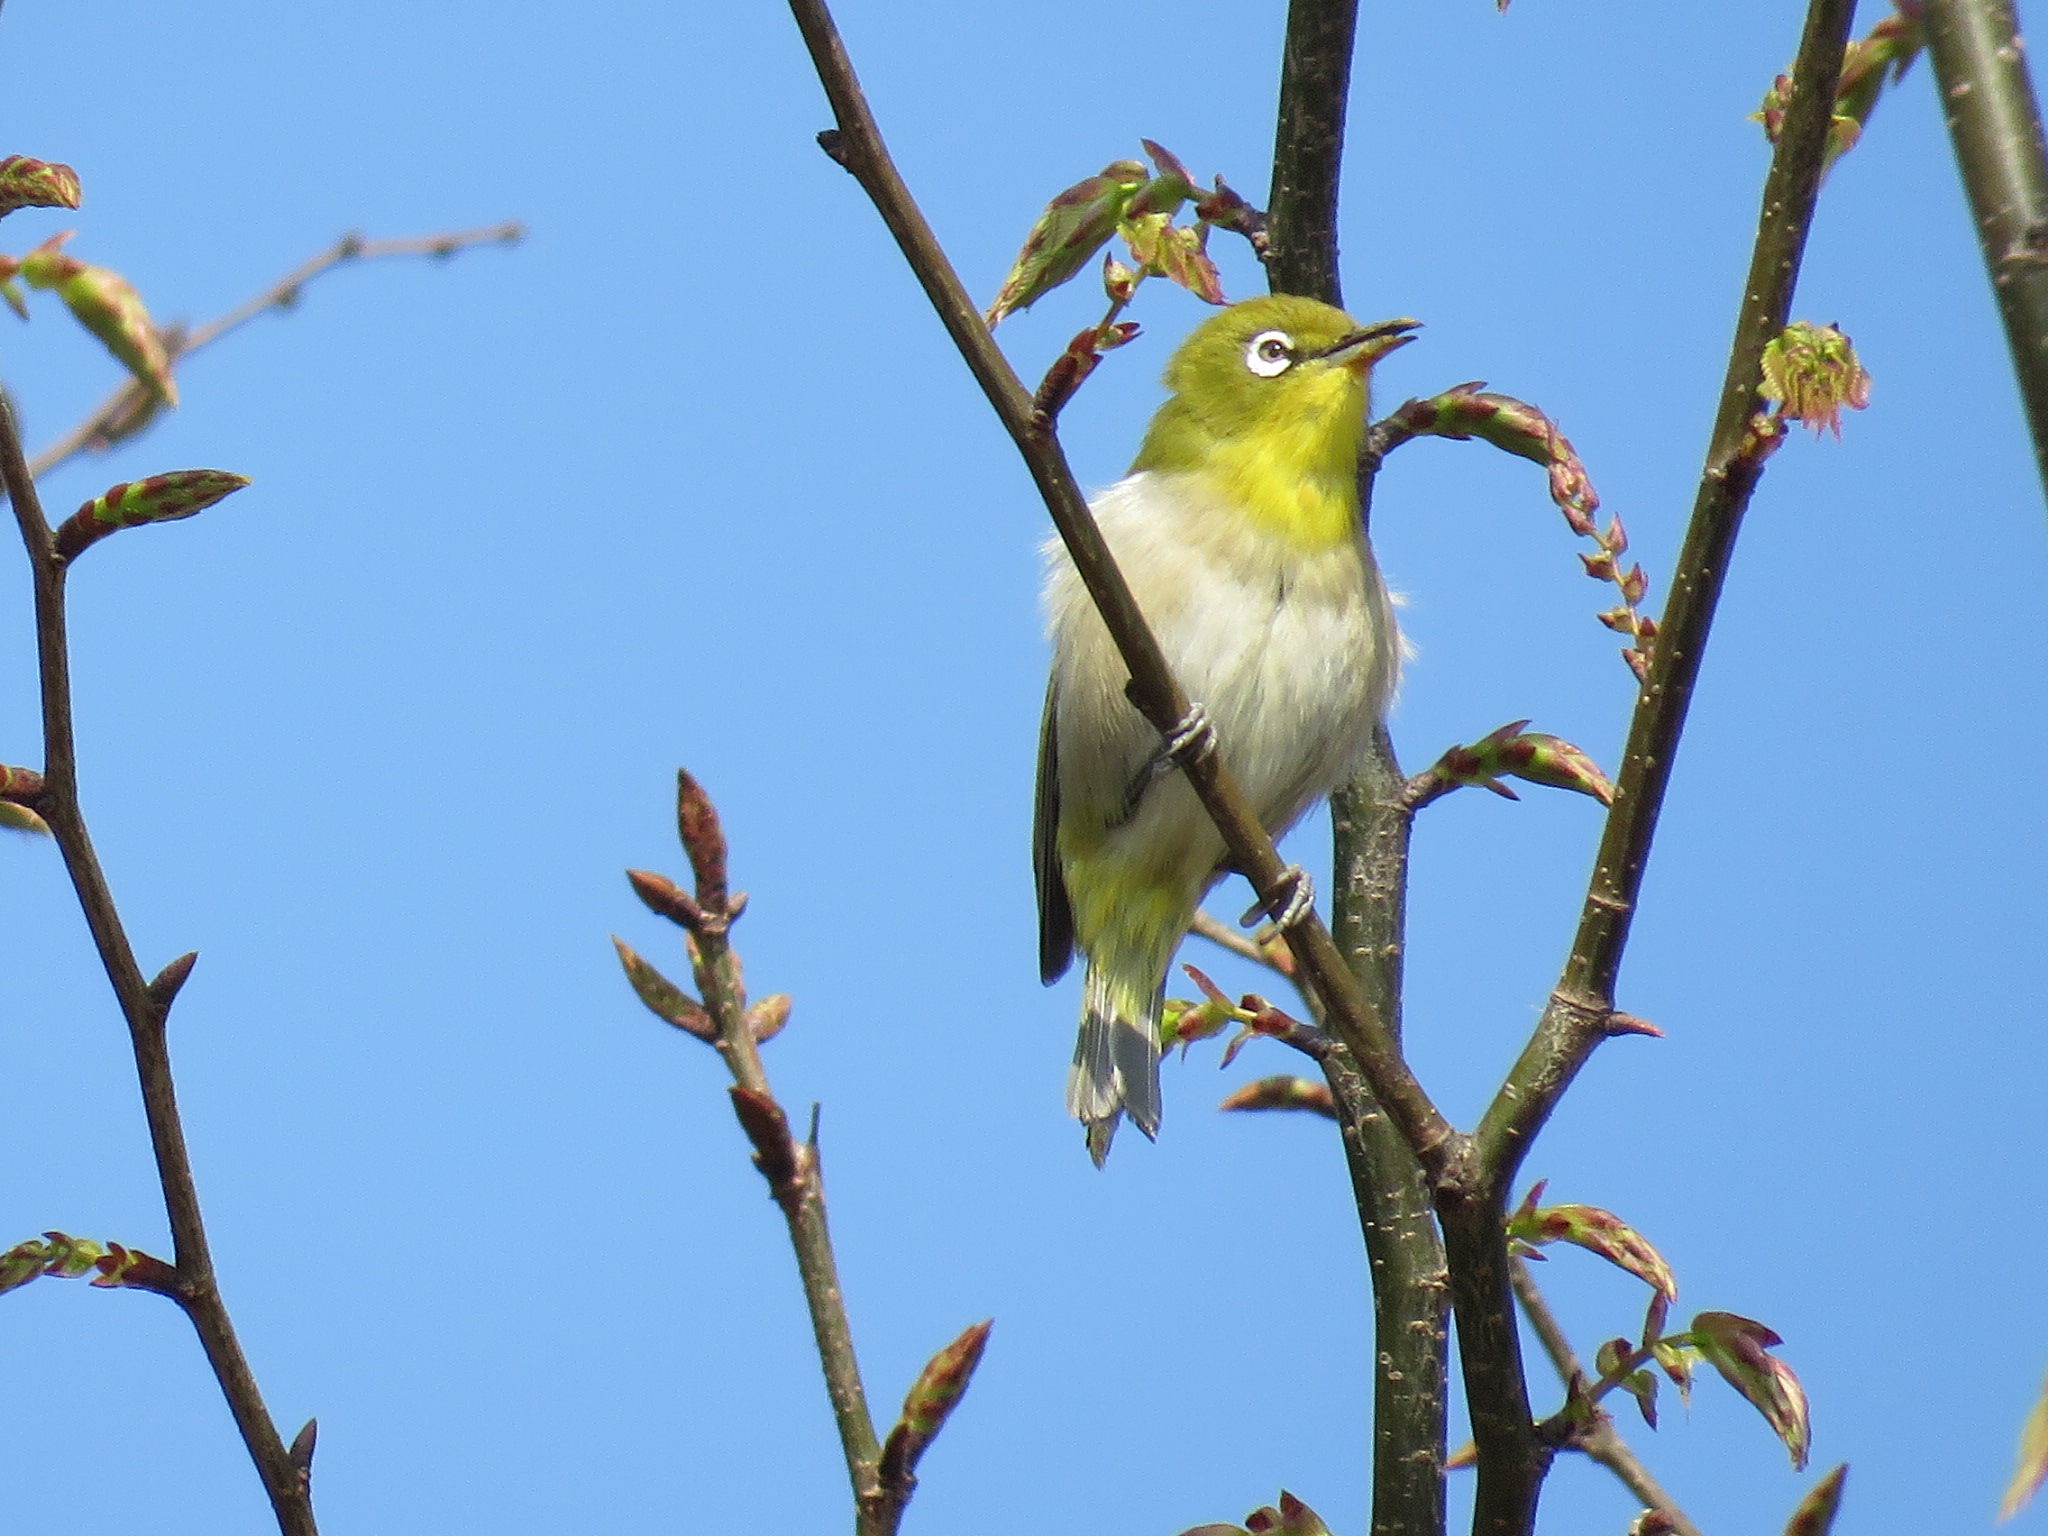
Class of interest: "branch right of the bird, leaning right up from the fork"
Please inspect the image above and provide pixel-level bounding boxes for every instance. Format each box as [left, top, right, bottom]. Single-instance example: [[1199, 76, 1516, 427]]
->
[[1477, 0, 1855, 1182]]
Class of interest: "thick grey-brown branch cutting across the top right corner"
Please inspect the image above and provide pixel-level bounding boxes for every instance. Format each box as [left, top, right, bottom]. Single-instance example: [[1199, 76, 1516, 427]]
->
[[1925, 0, 2048, 507]]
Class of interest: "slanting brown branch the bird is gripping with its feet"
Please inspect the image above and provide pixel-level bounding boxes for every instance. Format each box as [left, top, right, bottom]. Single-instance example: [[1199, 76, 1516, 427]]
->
[[788, 0, 1464, 1167]]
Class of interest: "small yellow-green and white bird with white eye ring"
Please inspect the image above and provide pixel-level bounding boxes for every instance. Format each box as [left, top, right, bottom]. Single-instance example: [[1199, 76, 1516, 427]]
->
[[1032, 295, 1415, 1165]]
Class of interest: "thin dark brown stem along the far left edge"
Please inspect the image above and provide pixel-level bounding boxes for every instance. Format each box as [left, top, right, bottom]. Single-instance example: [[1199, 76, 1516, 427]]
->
[[0, 399, 317, 1536]]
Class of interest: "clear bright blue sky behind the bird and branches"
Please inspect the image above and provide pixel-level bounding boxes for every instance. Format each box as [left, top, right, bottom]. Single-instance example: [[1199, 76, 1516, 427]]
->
[[0, 0, 2048, 1536]]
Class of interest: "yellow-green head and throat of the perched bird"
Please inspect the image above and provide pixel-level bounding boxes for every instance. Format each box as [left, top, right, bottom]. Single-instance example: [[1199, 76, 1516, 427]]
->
[[1130, 295, 1417, 547]]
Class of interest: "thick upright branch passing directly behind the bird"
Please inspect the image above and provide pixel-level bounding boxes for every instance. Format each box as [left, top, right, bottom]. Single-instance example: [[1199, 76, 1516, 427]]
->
[[1266, 0, 1450, 1536]]
